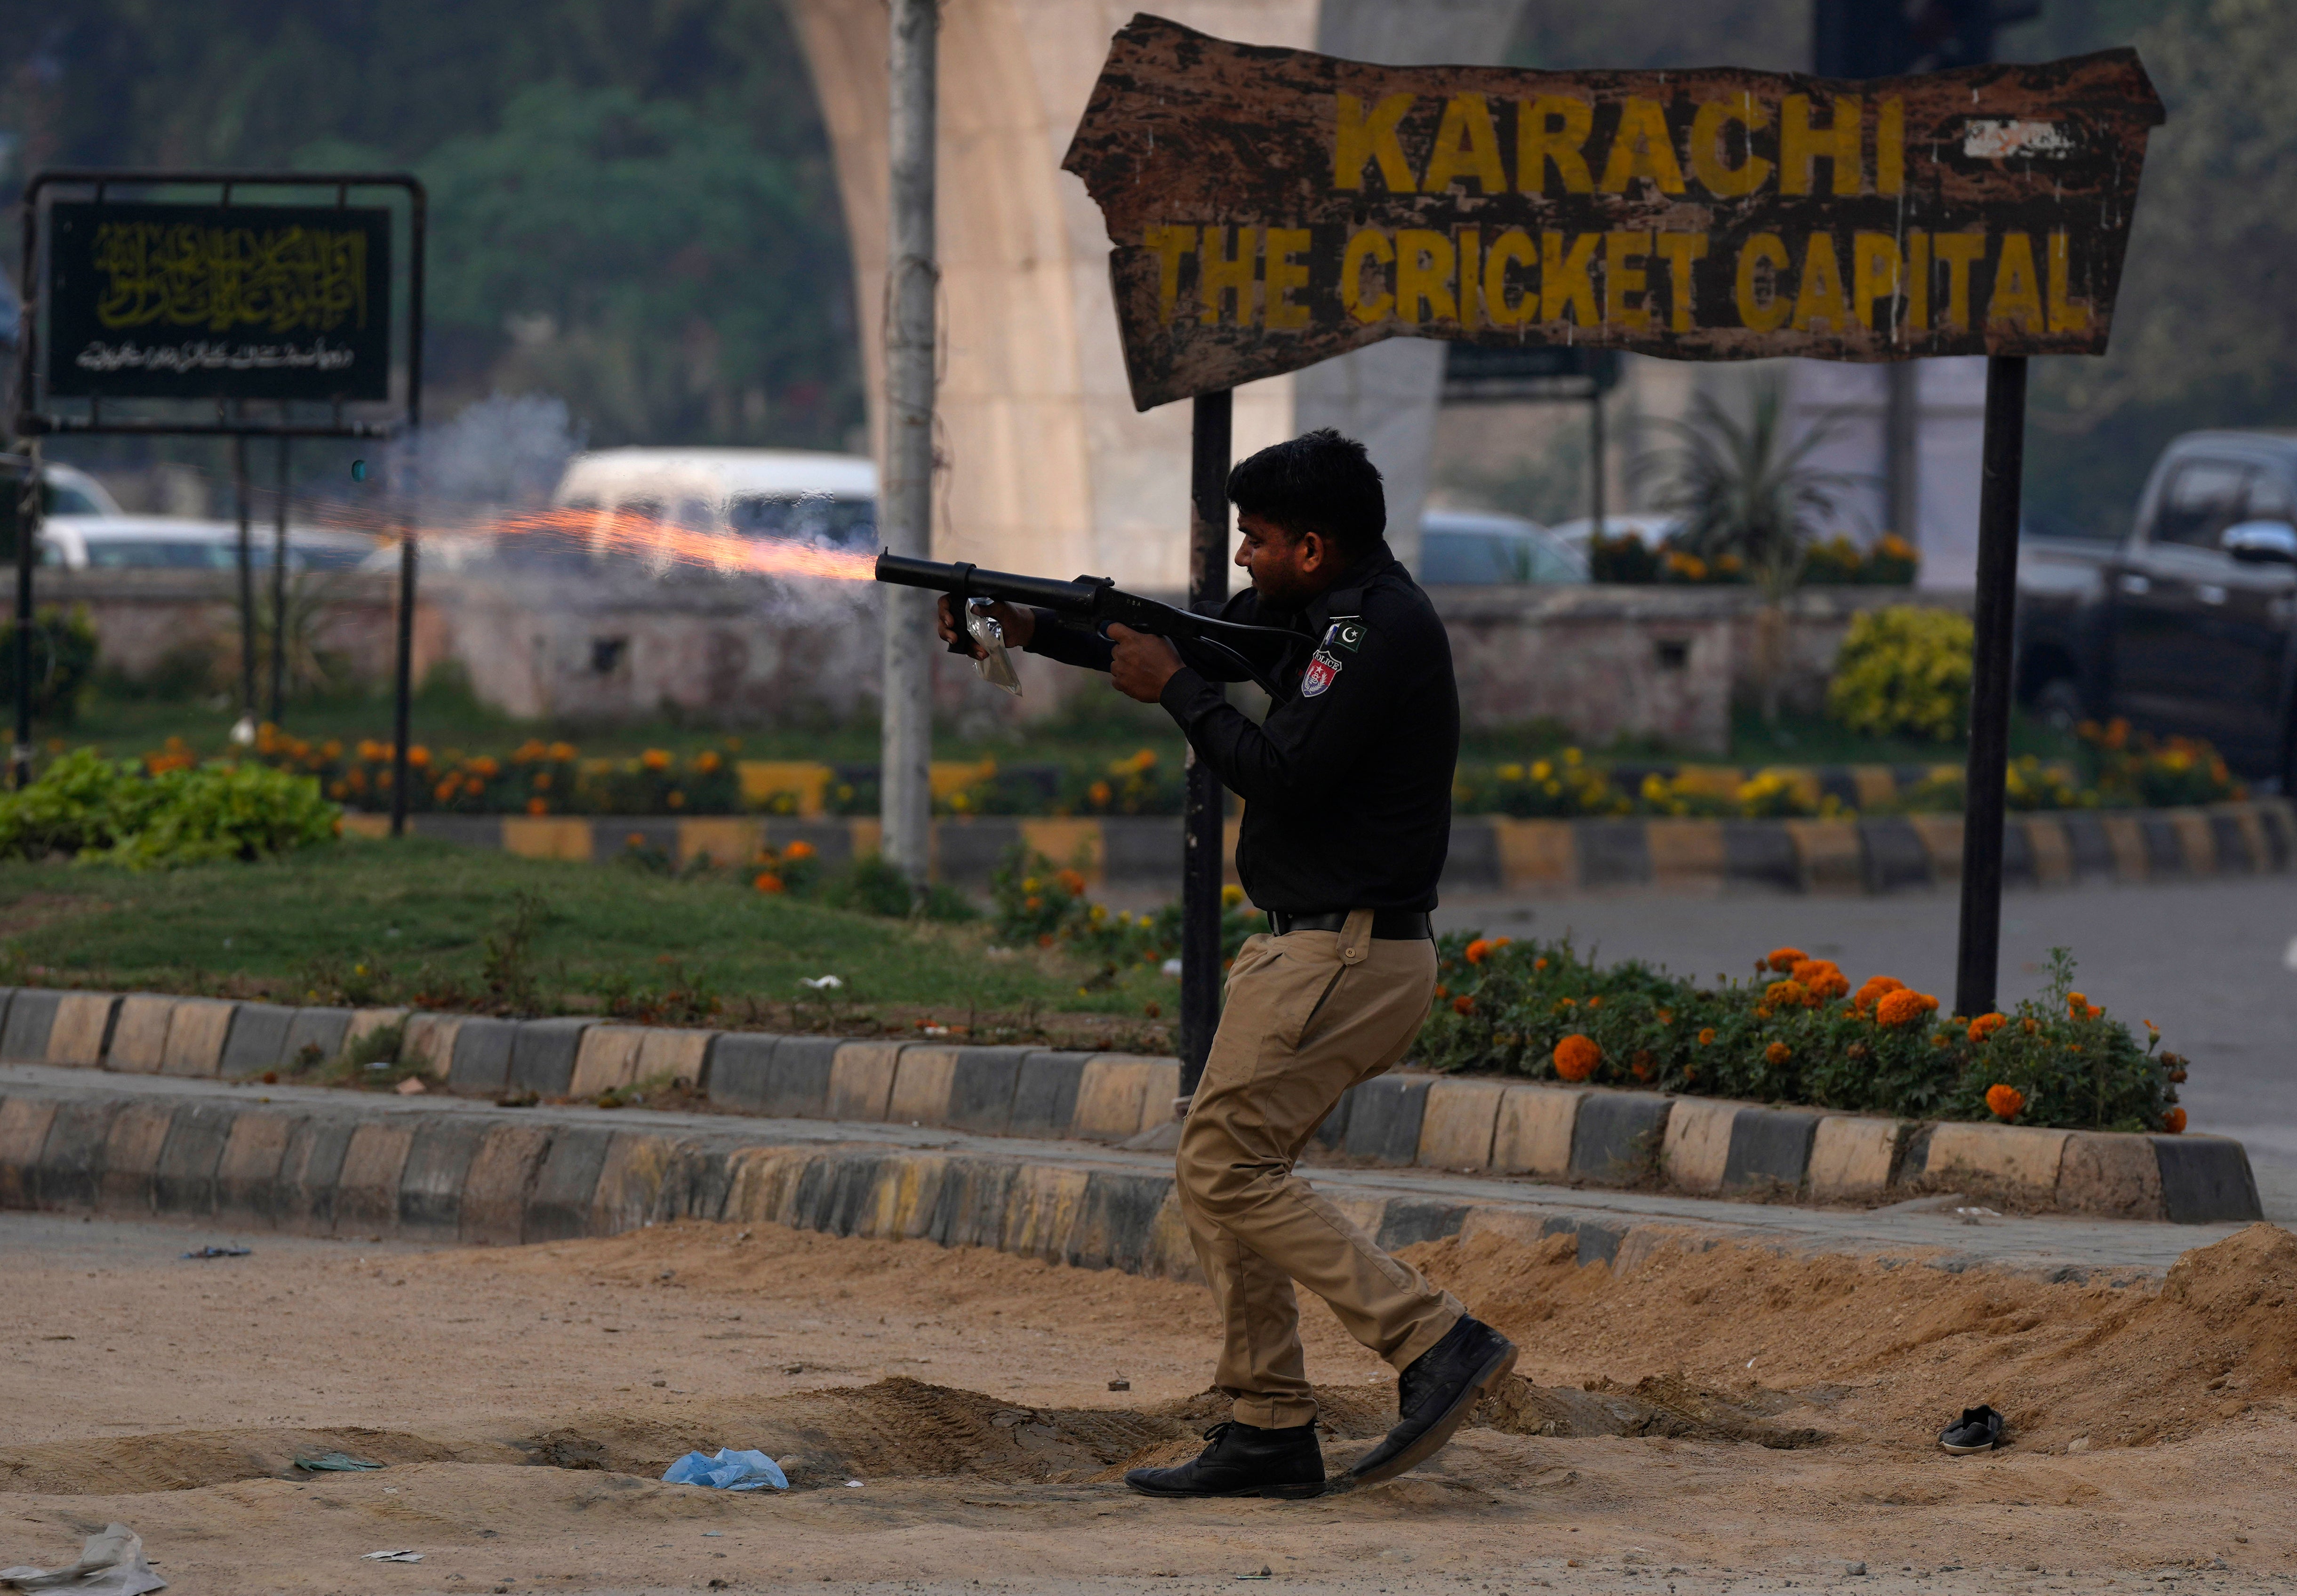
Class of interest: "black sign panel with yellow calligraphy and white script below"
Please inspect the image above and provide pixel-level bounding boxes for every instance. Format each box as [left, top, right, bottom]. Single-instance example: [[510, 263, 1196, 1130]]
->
[[44, 200, 391, 400]]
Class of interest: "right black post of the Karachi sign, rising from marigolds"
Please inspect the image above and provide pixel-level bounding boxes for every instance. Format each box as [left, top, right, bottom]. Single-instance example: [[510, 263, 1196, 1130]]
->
[[1955, 356, 2026, 1017]]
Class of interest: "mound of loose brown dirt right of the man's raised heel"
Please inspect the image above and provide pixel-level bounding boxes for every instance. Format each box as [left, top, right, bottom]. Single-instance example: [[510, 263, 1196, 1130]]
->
[[1406, 1224, 2297, 1447]]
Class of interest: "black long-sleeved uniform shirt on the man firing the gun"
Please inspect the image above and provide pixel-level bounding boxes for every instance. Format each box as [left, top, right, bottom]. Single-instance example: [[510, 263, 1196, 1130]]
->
[[1029, 544, 1458, 914]]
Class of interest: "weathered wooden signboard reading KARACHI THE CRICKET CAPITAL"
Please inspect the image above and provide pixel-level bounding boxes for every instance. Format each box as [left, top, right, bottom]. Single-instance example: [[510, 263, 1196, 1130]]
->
[[1064, 16, 2161, 409]]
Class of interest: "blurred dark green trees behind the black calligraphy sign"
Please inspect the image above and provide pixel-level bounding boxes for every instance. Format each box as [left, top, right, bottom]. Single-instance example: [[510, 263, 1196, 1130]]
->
[[0, 0, 861, 452]]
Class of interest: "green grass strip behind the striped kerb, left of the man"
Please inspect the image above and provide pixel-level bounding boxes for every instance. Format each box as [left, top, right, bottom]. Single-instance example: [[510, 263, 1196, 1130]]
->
[[0, 838, 1178, 1052]]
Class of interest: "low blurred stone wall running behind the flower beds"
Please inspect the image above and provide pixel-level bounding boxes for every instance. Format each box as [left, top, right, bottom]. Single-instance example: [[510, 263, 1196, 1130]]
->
[[39, 569, 1969, 755]]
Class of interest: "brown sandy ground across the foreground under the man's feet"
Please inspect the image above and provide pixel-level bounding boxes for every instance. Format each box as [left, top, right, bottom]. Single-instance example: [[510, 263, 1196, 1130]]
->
[[0, 1215, 2297, 1596]]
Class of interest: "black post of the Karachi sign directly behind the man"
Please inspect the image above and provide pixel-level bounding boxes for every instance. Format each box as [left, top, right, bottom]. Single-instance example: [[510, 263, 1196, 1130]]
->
[[1181, 388, 1236, 1098]]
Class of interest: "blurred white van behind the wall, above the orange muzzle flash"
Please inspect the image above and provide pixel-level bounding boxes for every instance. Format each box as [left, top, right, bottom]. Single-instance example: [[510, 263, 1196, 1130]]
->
[[551, 448, 878, 549]]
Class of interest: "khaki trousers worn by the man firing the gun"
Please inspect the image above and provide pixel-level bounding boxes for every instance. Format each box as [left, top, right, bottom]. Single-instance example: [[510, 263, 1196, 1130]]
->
[[1176, 909, 1461, 1428]]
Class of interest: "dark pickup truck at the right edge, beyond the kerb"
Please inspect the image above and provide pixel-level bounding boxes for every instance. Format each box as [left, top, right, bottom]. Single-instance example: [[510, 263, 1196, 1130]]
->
[[2017, 432, 2297, 790]]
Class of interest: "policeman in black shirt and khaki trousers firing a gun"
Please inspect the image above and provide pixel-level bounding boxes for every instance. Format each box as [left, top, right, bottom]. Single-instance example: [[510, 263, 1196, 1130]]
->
[[942, 429, 1516, 1497]]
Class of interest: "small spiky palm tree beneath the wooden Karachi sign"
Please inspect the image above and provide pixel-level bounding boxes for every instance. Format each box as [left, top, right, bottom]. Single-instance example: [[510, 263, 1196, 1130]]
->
[[1640, 372, 1851, 728]]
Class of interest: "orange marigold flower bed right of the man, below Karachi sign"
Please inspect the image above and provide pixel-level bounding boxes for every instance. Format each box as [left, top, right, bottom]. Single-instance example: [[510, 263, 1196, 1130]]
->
[[1419, 932, 2187, 1132]]
